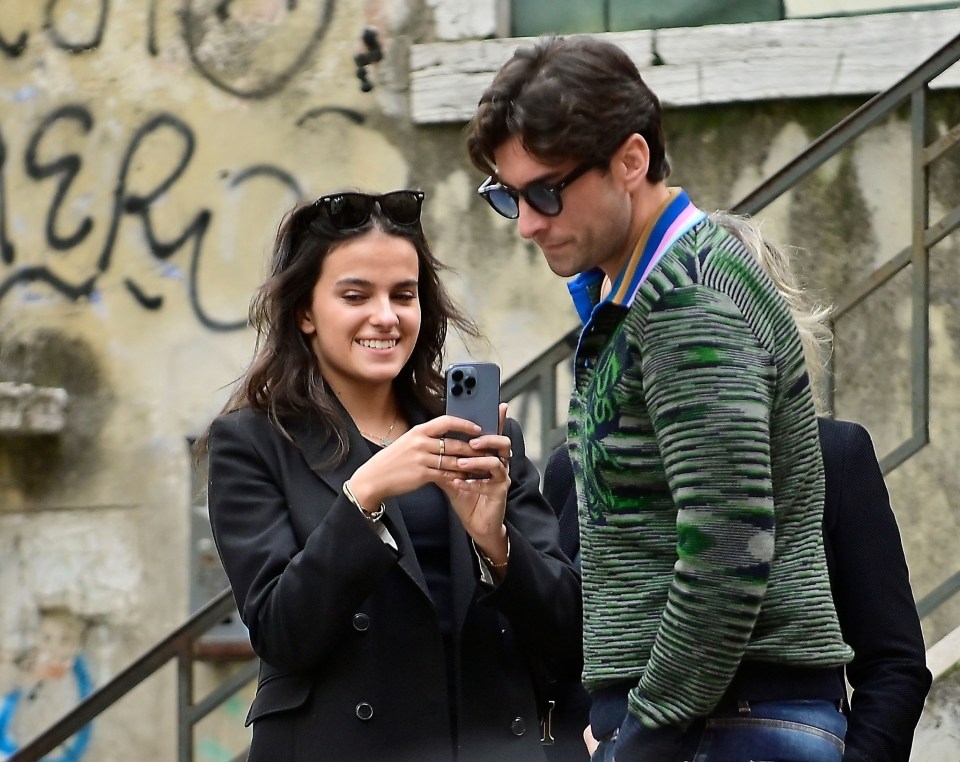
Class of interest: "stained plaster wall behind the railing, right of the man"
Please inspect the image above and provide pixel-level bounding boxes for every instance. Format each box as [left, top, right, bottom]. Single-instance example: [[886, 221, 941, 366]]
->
[[668, 91, 960, 644]]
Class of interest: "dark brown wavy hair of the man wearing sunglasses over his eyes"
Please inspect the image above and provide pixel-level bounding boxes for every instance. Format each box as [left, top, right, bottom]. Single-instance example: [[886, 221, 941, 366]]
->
[[467, 36, 670, 182]]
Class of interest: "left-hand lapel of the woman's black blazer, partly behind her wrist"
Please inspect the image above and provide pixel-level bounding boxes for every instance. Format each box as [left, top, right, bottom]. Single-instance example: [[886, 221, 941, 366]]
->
[[287, 411, 430, 598]]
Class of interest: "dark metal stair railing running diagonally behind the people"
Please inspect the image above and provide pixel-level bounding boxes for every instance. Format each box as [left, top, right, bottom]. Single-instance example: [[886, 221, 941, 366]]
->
[[8, 28, 960, 762]]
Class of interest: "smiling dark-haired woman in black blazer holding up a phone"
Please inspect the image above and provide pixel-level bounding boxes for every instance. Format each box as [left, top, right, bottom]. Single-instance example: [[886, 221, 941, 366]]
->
[[199, 190, 580, 762]]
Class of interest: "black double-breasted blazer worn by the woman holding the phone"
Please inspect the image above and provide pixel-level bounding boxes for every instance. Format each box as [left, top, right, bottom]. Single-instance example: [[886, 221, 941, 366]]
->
[[208, 409, 581, 762]]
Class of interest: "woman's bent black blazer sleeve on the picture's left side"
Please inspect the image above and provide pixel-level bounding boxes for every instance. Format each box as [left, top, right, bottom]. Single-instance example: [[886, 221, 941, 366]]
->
[[207, 414, 397, 673]]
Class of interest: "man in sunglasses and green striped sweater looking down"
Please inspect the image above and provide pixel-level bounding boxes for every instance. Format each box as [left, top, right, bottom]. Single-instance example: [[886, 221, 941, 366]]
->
[[467, 37, 851, 762]]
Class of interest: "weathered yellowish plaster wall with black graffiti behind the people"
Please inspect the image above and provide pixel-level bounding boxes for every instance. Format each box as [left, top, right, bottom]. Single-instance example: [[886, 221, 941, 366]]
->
[[0, 0, 960, 762]]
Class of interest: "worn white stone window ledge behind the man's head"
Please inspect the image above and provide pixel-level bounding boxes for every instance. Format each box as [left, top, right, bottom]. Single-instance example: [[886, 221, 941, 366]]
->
[[410, 9, 960, 124]]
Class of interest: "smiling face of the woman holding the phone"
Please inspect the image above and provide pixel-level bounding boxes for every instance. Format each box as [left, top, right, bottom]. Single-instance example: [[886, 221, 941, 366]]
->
[[299, 229, 420, 391]]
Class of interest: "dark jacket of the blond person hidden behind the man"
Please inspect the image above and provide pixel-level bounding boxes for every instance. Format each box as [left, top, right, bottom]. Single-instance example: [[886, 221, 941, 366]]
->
[[544, 418, 931, 762]]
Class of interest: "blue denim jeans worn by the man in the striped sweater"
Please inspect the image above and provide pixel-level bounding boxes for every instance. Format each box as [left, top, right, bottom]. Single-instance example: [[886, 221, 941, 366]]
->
[[591, 701, 847, 762]]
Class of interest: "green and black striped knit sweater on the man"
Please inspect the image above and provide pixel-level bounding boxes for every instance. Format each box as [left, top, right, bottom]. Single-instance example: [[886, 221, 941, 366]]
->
[[568, 215, 851, 728]]
